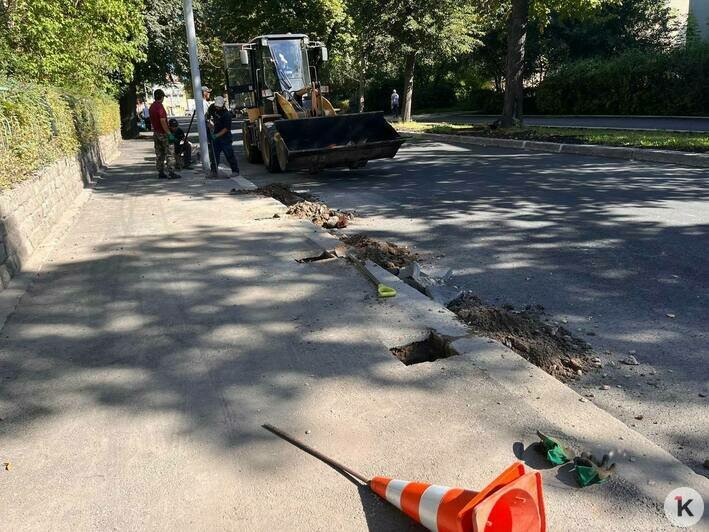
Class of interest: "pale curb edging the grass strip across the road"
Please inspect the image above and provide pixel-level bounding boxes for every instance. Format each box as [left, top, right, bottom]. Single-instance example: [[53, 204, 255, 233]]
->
[[401, 130, 709, 168]]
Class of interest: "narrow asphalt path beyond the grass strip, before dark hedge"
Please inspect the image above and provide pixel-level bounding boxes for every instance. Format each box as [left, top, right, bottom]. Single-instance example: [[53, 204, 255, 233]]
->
[[414, 112, 709, 131]]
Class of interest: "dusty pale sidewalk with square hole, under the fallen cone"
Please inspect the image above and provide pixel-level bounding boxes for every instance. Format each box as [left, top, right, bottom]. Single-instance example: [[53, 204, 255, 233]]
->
[[0, 141, 707, 531]]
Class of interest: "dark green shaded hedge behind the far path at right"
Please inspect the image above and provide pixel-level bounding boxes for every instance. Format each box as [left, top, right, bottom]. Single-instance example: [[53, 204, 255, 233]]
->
[[536, 44, 709, 115]]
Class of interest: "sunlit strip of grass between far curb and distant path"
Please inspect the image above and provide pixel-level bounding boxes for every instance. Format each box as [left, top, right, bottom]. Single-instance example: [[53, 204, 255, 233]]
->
[[393, 122, 709, 153]]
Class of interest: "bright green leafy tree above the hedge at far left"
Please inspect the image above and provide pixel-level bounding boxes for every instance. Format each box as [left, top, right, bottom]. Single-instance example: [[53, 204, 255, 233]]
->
[[0, 0, 145, 94]]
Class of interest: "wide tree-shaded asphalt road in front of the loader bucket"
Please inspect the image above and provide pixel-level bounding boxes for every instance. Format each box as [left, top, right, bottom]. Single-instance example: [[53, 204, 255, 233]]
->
[[242, 135, 709, 475]]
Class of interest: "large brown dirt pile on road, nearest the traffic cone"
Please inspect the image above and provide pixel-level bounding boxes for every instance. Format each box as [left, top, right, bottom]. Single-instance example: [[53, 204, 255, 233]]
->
[[448, 292, 592, 380]]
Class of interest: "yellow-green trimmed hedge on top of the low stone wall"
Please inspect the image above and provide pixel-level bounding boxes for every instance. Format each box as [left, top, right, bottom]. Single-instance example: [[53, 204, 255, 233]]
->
[[0, 79, 120, 189]]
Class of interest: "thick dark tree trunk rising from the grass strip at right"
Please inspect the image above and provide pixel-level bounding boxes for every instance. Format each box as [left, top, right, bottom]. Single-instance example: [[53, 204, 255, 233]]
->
[[502, 0, 529, 127]]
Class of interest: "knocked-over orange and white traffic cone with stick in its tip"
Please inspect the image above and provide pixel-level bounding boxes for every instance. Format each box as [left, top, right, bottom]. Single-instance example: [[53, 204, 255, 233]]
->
[[263, 425, 546, 532]]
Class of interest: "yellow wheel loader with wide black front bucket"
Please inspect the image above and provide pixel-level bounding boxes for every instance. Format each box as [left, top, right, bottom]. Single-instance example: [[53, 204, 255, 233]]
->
[[224, 33, 404, 173]]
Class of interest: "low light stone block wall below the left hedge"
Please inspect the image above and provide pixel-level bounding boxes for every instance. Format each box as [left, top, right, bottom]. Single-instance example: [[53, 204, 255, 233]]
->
[[0, 131, 121, 290]]
